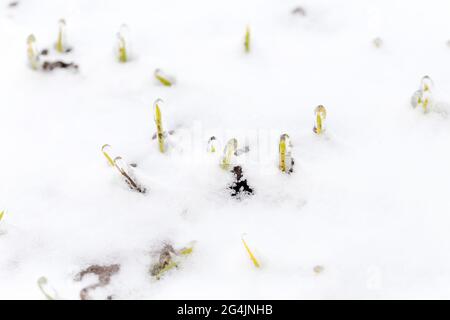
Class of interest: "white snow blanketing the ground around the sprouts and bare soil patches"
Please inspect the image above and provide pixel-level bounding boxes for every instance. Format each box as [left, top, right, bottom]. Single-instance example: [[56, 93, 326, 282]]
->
[[0, 0, 450, 299]]
